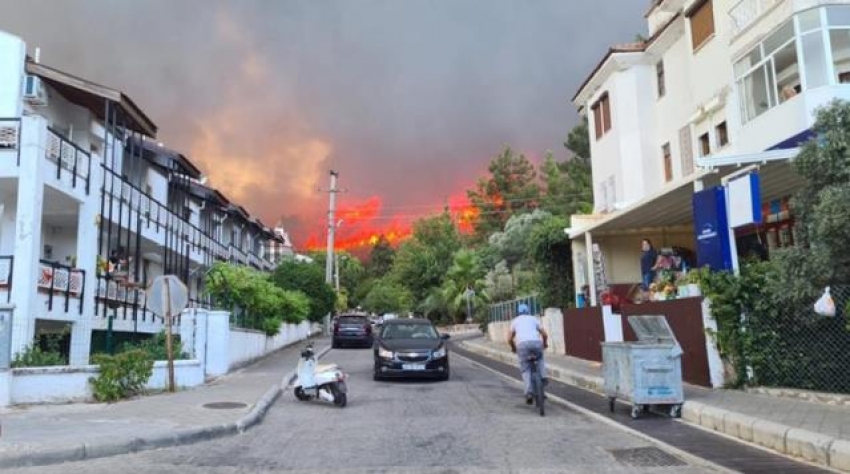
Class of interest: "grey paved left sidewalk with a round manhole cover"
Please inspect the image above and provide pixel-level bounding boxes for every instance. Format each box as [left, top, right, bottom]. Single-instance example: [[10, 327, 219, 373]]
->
[[0, 339, 330, 469]]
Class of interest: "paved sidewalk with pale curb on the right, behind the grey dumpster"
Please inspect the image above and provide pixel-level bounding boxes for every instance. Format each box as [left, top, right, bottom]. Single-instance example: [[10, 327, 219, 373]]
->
[[461, 338, 850, 472]]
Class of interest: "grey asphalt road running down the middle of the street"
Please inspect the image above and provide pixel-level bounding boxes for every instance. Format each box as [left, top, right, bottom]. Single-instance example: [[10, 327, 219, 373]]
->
[[9, 349, 724, 474]]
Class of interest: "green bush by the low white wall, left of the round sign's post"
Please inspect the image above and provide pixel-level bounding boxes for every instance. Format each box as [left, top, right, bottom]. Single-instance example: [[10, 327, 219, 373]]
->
[[89, 349, 153, 403]]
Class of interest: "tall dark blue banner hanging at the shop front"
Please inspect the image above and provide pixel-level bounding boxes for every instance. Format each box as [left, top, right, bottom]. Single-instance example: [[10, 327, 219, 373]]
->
[[693, 186, 732, 270]]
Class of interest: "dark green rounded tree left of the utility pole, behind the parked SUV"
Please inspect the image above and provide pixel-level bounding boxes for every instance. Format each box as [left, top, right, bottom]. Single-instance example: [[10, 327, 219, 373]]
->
[[272, 260, 336, 321]]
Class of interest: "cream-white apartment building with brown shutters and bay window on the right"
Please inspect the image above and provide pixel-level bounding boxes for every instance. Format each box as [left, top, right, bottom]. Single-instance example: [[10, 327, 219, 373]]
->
[[568, 0, 850, 300]]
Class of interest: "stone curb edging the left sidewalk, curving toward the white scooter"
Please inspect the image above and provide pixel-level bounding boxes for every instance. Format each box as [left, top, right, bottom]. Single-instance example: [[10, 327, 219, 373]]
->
[[0, 346, 331, 469]]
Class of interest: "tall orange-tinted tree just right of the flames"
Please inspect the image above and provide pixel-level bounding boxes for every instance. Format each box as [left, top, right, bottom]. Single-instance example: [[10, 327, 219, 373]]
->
[[466, 147, 540, 242]]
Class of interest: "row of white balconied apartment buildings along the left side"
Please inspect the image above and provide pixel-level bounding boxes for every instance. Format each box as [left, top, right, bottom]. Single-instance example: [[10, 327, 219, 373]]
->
[[0, 31, 280, 365]]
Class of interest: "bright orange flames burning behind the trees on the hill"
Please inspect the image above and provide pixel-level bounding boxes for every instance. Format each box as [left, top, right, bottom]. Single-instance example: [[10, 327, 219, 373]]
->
[[304, 194, 478, 251]]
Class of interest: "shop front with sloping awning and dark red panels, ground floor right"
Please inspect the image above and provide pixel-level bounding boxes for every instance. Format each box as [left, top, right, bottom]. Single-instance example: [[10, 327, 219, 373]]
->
[[563, 150, 801, 386]]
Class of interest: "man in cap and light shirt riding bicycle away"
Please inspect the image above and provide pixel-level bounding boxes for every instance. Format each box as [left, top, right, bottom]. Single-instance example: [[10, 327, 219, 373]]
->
[[508, 303, 549, 405]]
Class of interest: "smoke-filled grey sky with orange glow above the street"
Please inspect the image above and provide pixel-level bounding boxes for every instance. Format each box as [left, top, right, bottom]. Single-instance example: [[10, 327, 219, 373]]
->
[[0, 0, 649, 250]]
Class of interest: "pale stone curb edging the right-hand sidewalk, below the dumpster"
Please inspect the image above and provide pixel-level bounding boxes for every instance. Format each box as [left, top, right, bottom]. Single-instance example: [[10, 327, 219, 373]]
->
[[461, 341, 850, 472]]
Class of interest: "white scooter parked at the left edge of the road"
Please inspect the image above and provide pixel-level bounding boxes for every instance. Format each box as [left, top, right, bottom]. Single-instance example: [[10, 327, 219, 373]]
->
[[294, 342, 348, 408]]
